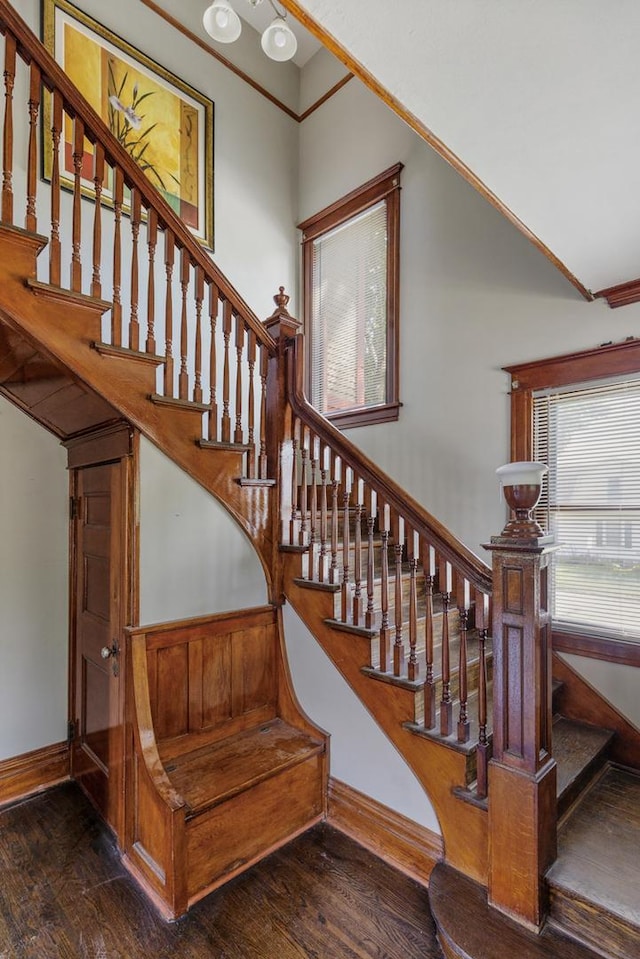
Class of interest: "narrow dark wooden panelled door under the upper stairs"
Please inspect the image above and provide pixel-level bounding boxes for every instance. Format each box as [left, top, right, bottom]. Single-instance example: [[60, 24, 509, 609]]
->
[[71, 459, 131, 839]]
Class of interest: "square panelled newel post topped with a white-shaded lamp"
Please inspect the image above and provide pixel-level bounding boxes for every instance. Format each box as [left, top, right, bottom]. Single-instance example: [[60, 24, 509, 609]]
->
[[487, 463, 557, 930]]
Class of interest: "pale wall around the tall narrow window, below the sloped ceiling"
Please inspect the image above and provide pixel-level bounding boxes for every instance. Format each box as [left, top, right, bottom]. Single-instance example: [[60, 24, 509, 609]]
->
[[300, 80, 640, 564]]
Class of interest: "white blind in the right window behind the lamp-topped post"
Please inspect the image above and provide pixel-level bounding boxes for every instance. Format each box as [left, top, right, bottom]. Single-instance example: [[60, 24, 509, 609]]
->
[[533, 378, 640, 642]]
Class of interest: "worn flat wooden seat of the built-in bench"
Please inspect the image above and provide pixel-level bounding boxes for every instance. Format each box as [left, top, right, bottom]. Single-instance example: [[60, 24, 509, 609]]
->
[[160, 719, 324, 816]]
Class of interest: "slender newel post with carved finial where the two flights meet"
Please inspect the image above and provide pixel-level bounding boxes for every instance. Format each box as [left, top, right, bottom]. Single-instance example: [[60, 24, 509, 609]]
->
[[264, 286, 301, 603]]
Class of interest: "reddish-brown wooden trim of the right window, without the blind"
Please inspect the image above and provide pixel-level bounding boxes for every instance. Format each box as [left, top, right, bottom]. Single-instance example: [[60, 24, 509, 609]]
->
[[503, 337, 640, 666]]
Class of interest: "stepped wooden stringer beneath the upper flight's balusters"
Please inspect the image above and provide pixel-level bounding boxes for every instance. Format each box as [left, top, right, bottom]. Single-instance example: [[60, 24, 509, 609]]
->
[[0, 251, 274, 593]]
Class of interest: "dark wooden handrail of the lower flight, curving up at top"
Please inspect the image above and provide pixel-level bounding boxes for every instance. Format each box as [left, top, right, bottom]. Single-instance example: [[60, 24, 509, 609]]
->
[[287, 335, 492, 593]]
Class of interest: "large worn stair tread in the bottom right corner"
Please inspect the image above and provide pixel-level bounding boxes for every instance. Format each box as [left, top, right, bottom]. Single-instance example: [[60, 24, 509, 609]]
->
[[547, 766, 640, 956]]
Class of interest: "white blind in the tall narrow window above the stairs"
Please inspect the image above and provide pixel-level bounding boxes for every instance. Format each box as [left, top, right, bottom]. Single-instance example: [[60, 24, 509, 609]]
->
[[311, 200, 388, 413]]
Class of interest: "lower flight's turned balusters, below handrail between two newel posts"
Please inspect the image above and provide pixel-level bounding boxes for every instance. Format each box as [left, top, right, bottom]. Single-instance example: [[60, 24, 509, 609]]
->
[[281, 416, 490, 798]]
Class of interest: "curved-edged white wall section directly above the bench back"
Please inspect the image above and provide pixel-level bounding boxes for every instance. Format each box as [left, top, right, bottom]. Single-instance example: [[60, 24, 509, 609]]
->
[[140, 439, 267, 624]]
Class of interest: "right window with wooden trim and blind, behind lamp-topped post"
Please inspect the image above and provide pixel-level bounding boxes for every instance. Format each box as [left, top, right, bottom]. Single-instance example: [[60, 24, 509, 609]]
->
[[507, 340, 640, 661]]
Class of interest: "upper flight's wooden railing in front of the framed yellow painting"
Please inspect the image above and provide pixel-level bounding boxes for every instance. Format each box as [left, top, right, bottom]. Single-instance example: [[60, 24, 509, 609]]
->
[[0, 9, 274, 479]]
